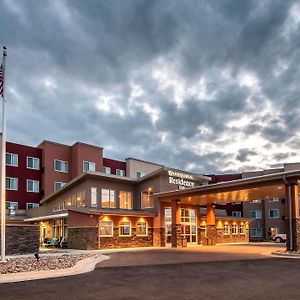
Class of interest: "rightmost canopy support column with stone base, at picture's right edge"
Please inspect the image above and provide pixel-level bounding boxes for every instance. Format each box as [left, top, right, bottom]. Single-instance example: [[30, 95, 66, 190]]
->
[[285, 180, 300, 251]]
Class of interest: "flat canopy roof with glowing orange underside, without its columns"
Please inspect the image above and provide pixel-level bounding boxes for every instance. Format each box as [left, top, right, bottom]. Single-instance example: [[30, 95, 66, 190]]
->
[[155, 170, 300, 205]]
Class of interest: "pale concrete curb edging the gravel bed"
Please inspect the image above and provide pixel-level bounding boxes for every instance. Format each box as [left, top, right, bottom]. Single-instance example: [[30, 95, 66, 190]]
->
[[0, 255, 110, 284]]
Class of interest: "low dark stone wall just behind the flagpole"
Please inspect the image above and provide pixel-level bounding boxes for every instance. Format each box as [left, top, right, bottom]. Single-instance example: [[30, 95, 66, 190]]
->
[[0, 224, 40, 255]]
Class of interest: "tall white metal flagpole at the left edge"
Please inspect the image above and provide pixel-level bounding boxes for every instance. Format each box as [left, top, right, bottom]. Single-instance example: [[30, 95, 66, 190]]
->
[[1, 46, 7, 262]]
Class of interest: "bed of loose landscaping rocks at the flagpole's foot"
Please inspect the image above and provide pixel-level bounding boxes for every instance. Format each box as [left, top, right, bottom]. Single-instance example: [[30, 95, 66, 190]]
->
[[0, 254, 95, 274]]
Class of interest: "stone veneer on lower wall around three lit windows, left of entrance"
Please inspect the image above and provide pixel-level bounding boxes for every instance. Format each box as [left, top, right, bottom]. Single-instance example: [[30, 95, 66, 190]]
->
[[68, 227, 153, 250]]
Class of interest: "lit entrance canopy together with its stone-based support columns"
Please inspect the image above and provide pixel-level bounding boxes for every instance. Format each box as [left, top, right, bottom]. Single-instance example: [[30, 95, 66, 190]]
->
[[155, 170, 300, 251]]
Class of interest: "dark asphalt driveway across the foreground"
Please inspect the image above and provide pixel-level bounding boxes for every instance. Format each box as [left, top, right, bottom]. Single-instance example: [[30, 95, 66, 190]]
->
[[0, 247, 300, 300]]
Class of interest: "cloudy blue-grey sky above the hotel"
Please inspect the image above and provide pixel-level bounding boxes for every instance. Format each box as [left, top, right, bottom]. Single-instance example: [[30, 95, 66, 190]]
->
[[0, 0, 300, 173]]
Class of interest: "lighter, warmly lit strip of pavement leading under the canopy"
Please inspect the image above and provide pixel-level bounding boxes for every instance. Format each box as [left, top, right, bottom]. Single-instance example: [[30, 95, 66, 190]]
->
[[97, 243, 285, 268]]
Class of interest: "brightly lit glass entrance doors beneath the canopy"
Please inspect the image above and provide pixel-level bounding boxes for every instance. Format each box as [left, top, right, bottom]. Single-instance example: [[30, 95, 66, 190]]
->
[[181, 208, 197, 245]]
